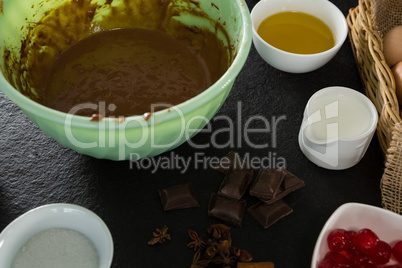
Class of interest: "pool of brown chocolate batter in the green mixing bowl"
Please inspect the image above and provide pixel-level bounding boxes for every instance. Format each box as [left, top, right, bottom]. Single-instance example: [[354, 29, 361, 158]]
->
[[43, 29, 211, 116]]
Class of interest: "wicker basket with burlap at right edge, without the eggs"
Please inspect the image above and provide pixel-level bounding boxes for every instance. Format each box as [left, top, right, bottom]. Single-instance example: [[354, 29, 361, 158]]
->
[[347, 0, 402, 214]]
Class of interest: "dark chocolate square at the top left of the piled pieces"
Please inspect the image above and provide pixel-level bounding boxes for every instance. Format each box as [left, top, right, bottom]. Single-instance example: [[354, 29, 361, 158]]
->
[[218, 169, 254, 200]]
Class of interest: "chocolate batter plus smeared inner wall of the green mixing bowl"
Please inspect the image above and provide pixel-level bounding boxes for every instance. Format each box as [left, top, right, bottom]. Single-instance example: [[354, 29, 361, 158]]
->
[[2, 0, 231, 117]]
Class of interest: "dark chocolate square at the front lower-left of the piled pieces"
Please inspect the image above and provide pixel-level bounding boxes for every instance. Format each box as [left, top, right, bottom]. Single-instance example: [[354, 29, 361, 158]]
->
[[208, 194, 246, 227]]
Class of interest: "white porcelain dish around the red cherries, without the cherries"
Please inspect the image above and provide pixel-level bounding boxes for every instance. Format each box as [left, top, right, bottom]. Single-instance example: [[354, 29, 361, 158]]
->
[[311, 203, 402, 268]]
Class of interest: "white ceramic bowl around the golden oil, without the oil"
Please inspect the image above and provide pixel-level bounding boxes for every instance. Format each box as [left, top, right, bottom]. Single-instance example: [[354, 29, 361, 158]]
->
[[251, 0, 348, 73]]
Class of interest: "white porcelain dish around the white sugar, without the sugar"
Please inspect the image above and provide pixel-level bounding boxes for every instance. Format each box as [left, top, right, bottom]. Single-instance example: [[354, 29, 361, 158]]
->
[[0, 204, 113, 268]]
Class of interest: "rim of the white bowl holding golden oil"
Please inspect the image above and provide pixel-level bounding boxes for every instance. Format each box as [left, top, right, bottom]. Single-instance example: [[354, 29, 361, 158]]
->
[[251, 0, 348, 59]]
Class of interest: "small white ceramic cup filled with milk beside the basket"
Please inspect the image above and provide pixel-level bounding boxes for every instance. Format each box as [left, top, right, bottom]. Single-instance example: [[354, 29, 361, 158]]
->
[[299, 86, 378, 170]]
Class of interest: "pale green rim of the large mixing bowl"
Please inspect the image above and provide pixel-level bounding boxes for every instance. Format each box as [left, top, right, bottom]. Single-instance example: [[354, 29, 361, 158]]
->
[[0, 0, 252, 130]]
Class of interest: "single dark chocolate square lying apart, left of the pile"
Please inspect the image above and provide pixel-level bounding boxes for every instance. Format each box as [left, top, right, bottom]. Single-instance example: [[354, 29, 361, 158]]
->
[[159, 184, 198, 211]]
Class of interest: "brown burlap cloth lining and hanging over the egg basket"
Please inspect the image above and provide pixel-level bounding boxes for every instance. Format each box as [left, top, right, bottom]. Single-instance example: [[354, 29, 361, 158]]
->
[[370, 0, 402, 214]]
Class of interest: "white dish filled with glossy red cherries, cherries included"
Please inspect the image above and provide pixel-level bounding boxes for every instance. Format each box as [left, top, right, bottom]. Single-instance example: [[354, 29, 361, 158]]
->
[[311, 203, 402, 268]]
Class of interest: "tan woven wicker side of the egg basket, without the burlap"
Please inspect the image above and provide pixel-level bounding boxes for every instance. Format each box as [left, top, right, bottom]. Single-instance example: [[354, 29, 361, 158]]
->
[[347, 0, 401, 154]]
